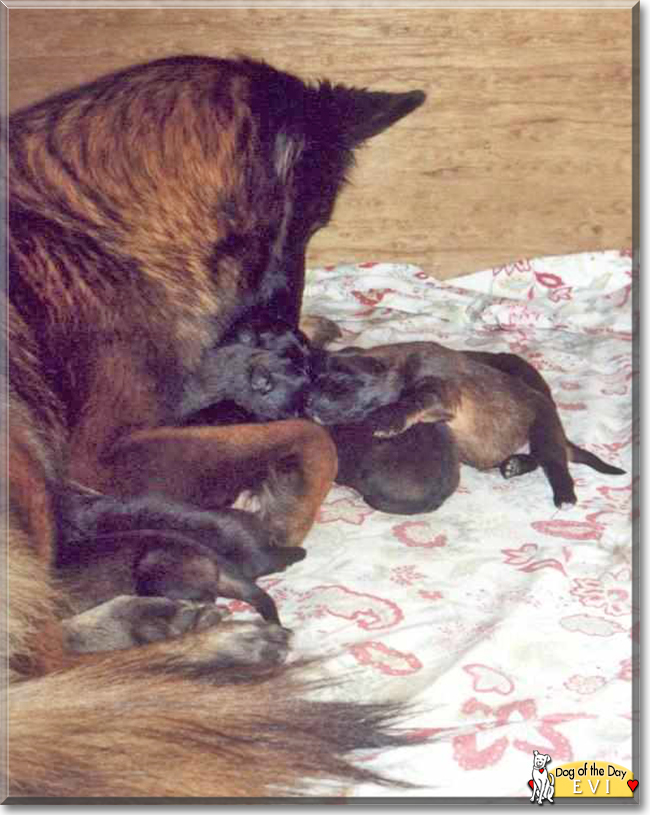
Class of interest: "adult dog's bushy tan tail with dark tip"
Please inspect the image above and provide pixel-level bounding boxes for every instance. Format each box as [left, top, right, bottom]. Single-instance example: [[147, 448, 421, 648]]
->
[[9, 648, 412, 801]]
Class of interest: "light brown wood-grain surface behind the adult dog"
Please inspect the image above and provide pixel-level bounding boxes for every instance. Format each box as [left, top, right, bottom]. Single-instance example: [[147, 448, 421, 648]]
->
[[8, 6, 632, 278]]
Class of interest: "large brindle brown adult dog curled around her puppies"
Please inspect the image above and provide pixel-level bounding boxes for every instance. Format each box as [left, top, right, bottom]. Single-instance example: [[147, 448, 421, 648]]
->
[[5, 57, 424, 797]]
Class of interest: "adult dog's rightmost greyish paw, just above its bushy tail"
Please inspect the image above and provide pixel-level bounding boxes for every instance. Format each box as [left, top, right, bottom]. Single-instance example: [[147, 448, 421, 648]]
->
[[209, 621, 291, 667]]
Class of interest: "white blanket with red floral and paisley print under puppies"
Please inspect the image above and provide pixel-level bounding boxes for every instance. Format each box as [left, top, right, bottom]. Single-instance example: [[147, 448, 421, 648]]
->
[[225, 251, 638, 798]]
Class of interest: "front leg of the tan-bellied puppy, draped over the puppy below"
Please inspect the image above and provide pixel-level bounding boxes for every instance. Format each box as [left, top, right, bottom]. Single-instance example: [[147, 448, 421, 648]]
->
[[366, 377, 458, 438]]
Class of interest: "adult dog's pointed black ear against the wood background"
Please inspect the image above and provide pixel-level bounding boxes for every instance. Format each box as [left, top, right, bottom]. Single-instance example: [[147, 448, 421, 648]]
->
[[324, 85, 426, 147]]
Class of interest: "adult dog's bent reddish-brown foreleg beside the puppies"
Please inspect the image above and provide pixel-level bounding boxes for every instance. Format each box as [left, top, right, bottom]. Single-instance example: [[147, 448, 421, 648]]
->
[[107, 419, 337, 546]]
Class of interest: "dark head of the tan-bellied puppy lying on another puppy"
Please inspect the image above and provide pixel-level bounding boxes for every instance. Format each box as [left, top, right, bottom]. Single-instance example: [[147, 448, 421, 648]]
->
[[305, 353, 395, 425]]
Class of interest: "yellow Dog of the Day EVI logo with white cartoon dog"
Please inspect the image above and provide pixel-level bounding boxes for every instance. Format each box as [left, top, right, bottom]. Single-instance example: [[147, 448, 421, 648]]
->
[[528, 750, 639, 805]]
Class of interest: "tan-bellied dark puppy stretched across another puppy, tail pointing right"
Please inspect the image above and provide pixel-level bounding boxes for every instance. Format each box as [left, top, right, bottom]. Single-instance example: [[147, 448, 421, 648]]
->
[[306, 342, 624, 507]]
